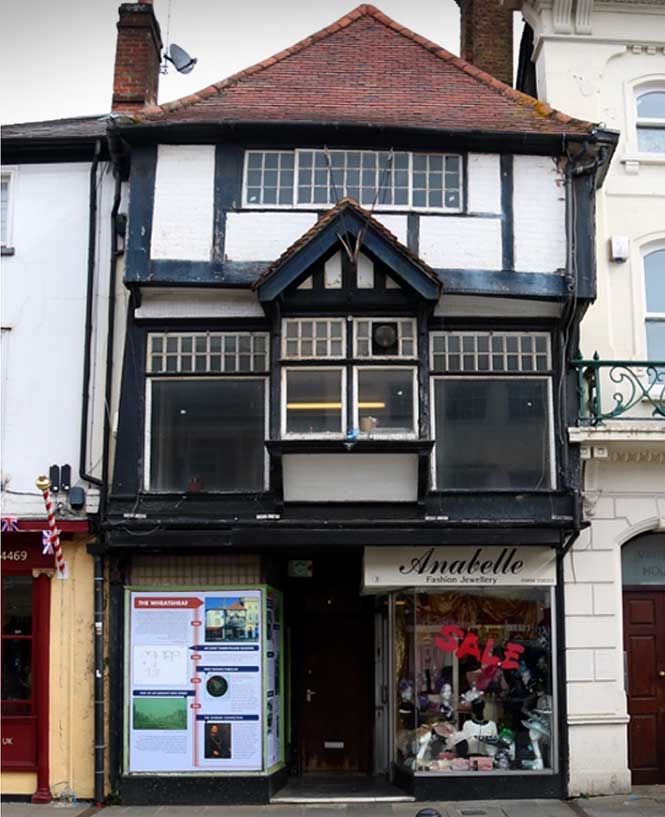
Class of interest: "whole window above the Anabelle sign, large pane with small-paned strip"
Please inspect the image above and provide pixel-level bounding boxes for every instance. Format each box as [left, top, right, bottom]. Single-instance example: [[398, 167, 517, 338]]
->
[[430, 332, 555, 491]]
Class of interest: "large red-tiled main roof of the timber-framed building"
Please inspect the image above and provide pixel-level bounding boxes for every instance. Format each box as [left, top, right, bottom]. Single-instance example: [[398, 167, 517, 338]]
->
[[135, 5, 593, 134]]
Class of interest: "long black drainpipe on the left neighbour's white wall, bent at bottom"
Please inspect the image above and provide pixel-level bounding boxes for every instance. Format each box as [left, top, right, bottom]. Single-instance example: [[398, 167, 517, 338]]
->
[[79, 139, 103, 487]]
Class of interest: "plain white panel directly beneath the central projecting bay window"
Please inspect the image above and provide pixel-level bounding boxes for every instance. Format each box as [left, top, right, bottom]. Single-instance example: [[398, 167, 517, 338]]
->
[[283, 454, 418, 502]]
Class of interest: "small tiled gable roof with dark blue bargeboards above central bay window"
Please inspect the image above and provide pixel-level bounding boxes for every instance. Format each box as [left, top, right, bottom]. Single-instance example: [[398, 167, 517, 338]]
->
[[253, 198, 441, 302]]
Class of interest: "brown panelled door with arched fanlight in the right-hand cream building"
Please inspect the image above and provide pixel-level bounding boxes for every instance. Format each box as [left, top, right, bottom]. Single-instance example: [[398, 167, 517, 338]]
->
[[622, 534, 665, 785]]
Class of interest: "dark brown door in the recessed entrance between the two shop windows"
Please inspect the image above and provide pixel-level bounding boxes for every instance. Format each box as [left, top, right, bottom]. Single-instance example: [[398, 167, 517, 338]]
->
[[292, 563, 374, 775]]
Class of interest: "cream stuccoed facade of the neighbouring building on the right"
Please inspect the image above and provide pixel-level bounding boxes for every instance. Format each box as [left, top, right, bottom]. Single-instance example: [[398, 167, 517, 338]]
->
[[505, 0, 665, 795]]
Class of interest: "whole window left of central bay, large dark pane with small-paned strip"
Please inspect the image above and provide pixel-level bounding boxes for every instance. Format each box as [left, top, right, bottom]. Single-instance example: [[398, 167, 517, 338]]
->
[[145, 332, 269, 493]]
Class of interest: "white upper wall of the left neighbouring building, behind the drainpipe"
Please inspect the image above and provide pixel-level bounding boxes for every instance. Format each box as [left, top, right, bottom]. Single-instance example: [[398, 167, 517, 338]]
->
[[1, 163, 114, 517]]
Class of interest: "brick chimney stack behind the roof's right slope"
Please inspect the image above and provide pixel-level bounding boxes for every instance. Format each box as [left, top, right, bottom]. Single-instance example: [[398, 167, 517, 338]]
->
[[456, 0, 513, 85]]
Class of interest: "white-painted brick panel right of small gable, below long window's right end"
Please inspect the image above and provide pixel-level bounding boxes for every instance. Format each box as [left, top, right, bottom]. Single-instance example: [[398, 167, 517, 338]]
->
[[419, 216, 502, 270]]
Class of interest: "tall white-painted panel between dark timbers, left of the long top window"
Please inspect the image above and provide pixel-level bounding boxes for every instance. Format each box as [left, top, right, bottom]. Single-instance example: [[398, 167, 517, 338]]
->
[[151, 145, 215, 261]]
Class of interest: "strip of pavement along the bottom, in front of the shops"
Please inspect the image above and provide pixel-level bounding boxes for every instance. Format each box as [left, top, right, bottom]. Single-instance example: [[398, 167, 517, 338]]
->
[[2, 786, 665, 817]]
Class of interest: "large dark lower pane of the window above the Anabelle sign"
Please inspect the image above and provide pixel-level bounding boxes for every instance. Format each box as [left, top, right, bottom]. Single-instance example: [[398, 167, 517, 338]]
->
[[434, 378, 551, 490]]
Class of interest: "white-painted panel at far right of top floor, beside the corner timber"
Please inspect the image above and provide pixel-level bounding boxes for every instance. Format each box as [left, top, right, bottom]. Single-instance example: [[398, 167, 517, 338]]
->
[[513, 156, 566, 272]]
